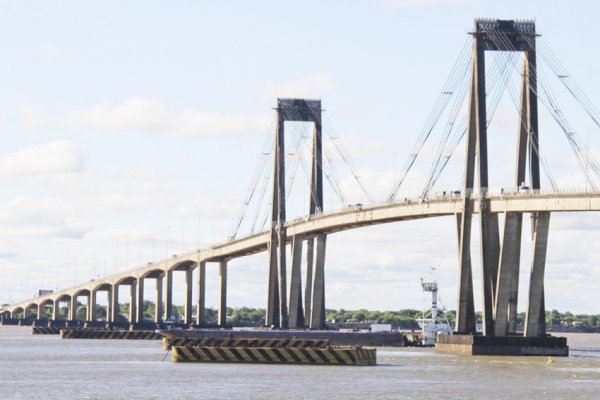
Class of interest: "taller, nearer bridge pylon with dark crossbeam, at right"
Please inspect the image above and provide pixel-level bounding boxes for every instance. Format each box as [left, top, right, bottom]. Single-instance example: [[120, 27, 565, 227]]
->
[[456, 19, 550, 336]]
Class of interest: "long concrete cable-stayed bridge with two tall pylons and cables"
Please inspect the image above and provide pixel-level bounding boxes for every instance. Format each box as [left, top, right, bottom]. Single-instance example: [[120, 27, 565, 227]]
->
[[0, 20, 600, 337]]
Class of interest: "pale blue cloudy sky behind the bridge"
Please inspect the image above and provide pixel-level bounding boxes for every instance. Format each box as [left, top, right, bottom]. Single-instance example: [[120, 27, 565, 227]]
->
[[0, 0, 600, 313]]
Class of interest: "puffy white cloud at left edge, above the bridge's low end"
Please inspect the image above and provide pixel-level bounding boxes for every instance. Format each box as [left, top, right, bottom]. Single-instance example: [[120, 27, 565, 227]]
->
[[0, 141, 84, 176]]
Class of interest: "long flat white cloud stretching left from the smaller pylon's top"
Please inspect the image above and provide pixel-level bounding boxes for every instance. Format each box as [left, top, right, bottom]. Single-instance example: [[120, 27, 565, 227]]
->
[[20, 97, 271, 137]]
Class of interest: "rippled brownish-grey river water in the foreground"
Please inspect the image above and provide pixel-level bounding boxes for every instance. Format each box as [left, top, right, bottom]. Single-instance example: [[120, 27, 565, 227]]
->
[[0, 326, 600, 400]]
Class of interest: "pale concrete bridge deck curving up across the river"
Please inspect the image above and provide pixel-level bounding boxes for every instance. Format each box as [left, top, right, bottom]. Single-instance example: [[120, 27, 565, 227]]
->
[[0, 191, 600, 312]]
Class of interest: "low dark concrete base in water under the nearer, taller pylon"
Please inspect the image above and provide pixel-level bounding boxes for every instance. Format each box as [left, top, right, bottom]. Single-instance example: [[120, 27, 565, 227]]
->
[[435, 334, 569, 357]]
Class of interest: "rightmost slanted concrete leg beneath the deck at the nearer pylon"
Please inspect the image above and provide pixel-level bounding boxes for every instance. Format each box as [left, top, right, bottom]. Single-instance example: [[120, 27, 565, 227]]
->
[[525, 212, 550, 337]]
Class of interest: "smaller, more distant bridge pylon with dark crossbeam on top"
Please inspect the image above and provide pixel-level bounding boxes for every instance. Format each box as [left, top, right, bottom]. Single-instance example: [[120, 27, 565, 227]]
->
[[265, 99, 326, 329]]
